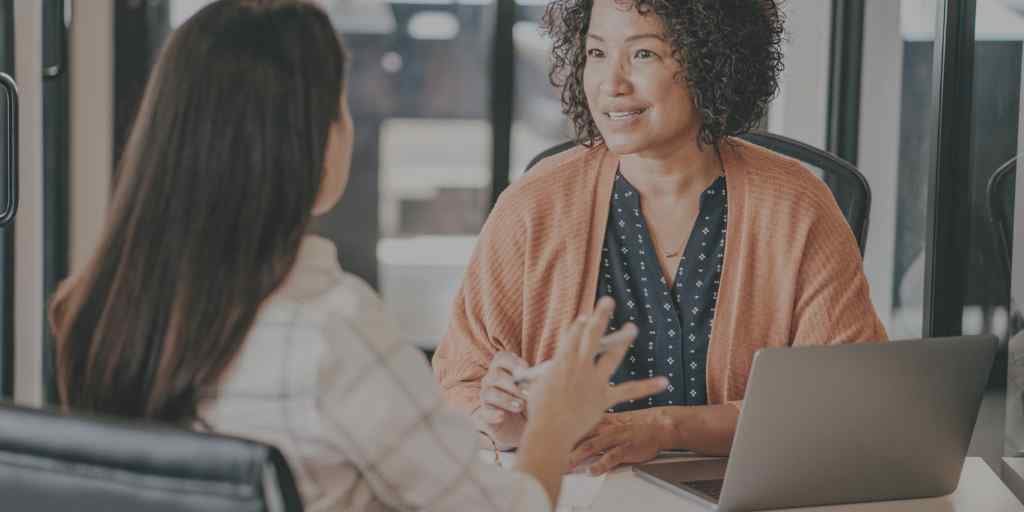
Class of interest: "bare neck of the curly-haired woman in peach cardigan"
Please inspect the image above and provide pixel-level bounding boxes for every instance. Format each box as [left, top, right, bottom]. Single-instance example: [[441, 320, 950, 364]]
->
[[620, 140, 723, 201]]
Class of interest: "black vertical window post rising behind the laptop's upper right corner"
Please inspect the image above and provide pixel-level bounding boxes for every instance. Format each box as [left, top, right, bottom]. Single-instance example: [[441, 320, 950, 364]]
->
[[923, 0, 976, 337]]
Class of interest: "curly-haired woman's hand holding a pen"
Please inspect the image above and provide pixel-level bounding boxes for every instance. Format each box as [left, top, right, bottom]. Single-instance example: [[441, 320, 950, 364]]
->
[[473, 352, 528, 450]]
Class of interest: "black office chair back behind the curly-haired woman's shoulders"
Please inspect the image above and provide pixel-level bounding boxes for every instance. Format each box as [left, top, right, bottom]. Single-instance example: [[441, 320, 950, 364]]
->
[[526, 132, 871, 254]]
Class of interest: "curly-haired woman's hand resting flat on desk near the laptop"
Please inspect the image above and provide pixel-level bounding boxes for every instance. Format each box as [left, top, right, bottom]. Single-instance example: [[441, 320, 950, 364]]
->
[[569, 409, 669, 475]]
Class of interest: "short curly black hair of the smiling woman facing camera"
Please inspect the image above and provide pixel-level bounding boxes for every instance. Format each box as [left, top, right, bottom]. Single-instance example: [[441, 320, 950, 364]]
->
[[542, 0, 783, 147]]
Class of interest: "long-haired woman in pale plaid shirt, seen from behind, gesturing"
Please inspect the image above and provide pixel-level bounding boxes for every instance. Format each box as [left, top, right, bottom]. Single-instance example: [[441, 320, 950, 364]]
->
[[51, 0, 664, 510]]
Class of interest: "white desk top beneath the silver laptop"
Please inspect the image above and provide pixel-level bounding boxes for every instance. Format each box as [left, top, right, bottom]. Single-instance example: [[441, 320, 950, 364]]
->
[[559, 457, 1024, 512]]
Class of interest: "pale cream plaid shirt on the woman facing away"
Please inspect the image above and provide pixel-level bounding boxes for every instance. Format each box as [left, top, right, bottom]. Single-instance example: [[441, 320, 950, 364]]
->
[[201, 237, 550, 511]]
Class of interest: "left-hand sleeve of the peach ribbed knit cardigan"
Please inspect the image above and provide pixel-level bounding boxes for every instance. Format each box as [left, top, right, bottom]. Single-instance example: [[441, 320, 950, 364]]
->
[[433, 190, 526, 414]]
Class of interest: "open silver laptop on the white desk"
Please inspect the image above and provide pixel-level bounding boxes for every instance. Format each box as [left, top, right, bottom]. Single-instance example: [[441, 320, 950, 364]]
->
[[634, 336, 996, 512]]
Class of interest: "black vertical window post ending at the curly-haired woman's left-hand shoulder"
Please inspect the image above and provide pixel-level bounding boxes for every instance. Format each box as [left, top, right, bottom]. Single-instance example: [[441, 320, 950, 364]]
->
[[490, 0, 516, 207]]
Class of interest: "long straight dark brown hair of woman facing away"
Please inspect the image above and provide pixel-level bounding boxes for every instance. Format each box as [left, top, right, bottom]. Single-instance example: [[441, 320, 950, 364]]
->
[[50, 0, 350, 422]]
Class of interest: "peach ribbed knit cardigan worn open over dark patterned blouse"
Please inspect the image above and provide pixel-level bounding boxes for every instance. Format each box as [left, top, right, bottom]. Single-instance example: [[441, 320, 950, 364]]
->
[[433, 139, 887, 413]]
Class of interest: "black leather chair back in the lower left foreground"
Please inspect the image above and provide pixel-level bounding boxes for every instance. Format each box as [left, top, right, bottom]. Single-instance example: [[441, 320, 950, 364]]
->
[[0, 404, 302, 512]]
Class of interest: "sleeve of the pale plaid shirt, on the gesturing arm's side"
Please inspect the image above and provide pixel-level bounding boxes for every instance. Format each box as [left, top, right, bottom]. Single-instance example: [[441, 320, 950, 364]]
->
[[316, 276, 550, 511]]
